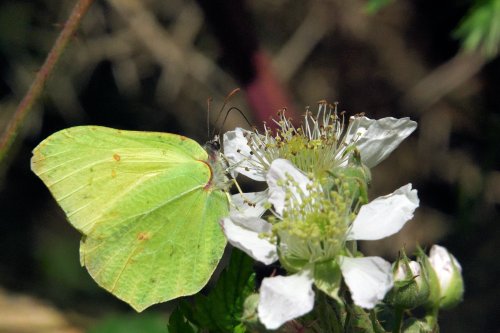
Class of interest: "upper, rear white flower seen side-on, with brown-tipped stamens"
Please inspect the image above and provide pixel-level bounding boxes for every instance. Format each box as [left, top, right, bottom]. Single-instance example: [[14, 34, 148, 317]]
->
[[223, 102, 417, 181]]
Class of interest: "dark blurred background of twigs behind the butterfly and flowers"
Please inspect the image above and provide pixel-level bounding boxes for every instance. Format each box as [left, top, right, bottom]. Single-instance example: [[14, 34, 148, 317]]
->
[[0, 0, 500, 332]]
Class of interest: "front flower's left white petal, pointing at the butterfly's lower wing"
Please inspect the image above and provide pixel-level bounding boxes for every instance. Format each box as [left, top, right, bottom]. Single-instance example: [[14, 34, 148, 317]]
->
[[221, 215, 278, 265]]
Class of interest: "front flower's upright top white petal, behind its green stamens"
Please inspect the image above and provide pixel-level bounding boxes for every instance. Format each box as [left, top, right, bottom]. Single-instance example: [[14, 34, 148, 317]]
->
[[266, 159, 311, 215]]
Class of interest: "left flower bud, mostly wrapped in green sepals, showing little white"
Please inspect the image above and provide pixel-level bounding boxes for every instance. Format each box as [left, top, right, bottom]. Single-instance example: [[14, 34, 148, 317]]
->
[[386, 253, 429, 309]]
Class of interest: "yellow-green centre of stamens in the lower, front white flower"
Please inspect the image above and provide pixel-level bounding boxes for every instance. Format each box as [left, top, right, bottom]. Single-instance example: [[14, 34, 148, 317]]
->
[[270, 179, 355, 271]]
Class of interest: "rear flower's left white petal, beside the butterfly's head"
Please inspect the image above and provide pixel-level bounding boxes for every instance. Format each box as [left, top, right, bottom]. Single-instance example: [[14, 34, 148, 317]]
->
[[223, 127, 266, 181]]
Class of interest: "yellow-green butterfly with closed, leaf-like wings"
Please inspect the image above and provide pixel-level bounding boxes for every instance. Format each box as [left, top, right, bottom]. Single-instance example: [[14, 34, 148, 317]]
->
[[31, 126, 229, 311]]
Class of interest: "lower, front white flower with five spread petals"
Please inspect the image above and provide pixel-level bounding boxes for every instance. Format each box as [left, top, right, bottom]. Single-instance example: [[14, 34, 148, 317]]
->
[[222, 159, 419, 329]]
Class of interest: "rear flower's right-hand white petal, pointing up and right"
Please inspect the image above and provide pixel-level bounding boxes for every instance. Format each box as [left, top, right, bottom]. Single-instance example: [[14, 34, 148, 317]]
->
[[346, 117, 417, 168]]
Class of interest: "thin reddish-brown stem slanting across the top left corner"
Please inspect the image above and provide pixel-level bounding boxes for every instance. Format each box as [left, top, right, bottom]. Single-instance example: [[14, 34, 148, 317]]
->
[[0, 0, 94, 162]]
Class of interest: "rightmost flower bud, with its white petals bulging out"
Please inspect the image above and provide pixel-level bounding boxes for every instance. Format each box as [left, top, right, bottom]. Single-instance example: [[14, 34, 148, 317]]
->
[[428, 245, 464, 309]]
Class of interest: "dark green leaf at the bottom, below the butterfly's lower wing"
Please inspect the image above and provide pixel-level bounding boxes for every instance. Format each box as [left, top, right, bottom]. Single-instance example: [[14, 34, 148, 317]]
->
[[181, 249, 255, 333]]
